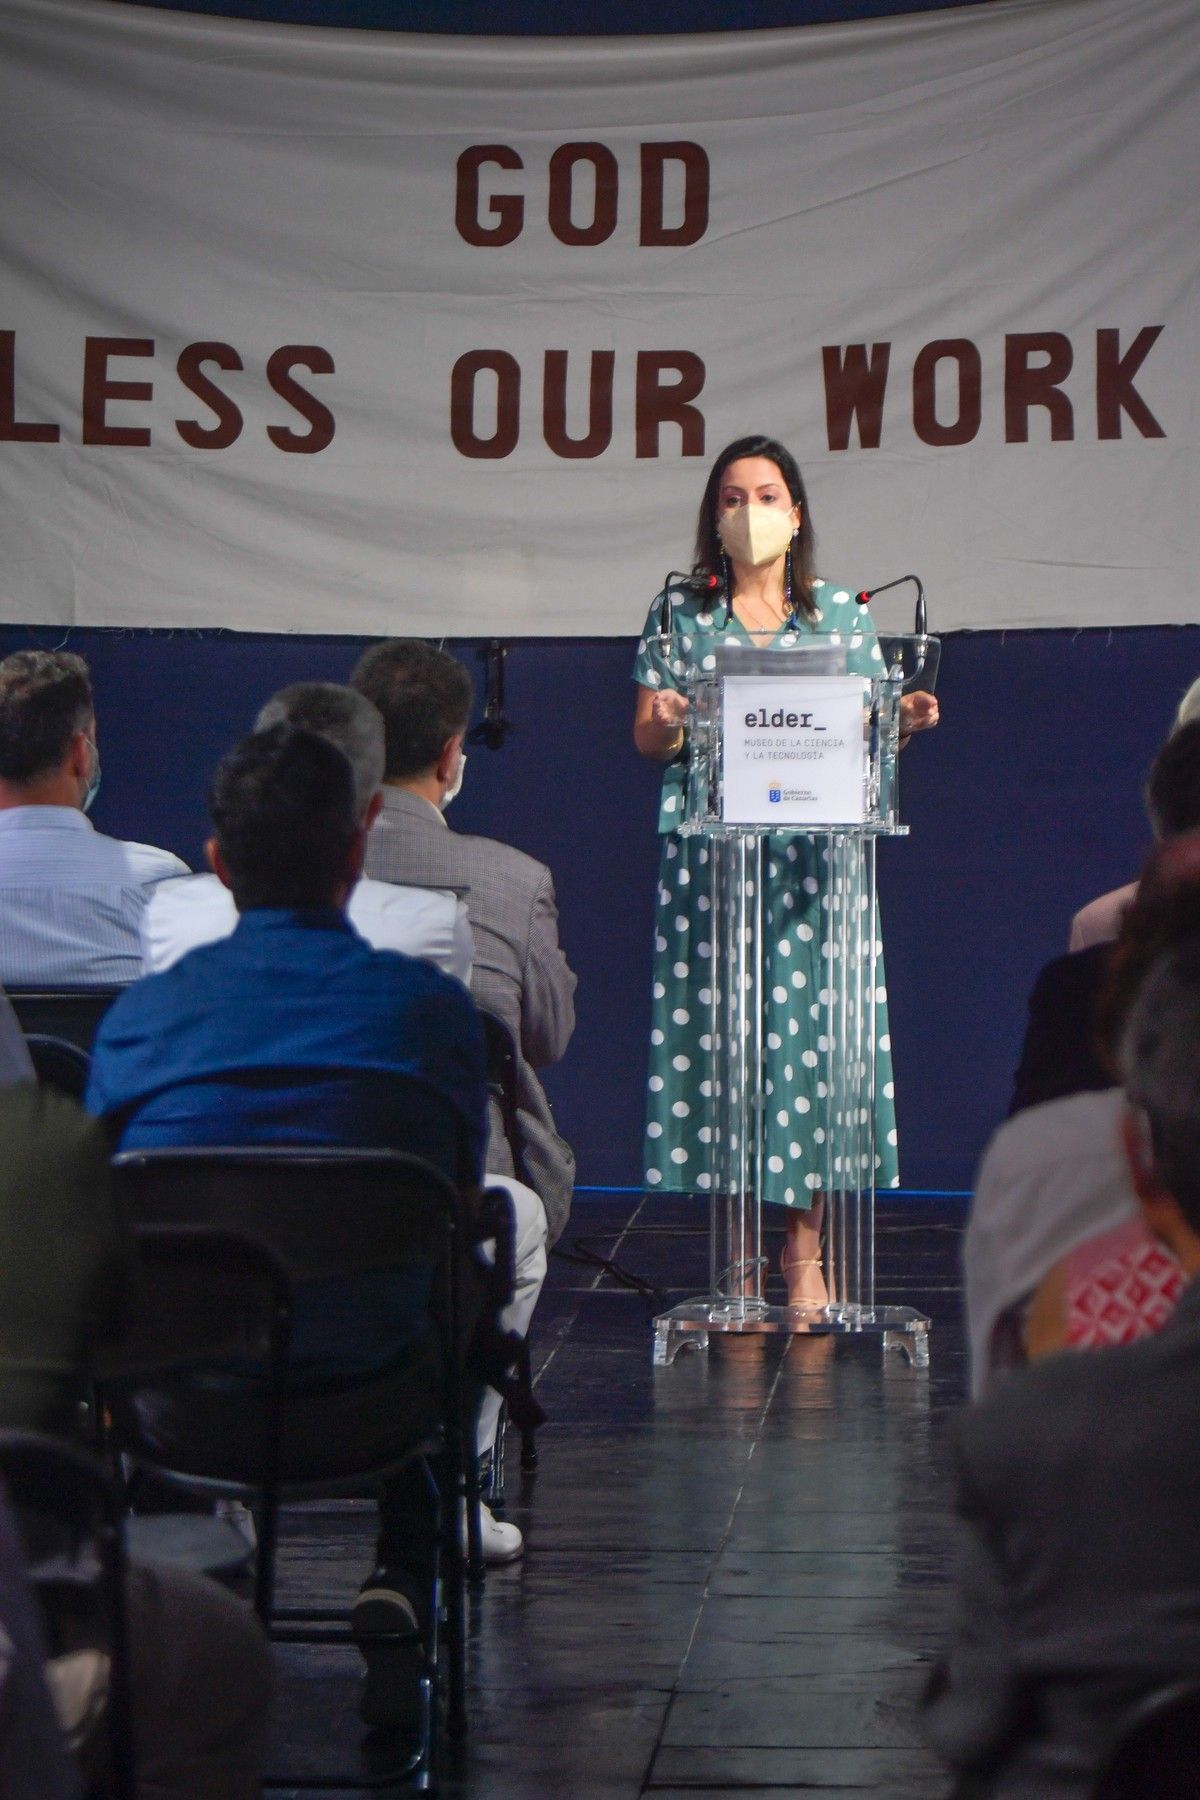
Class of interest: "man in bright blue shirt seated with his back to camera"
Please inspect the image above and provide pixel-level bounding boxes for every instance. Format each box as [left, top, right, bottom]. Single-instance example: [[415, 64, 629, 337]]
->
[[88, 725, 486, 1724]]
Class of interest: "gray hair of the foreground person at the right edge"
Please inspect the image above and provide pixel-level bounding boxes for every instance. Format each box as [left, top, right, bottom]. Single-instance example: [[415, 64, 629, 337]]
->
[[1117, 936, 1200, 1229]]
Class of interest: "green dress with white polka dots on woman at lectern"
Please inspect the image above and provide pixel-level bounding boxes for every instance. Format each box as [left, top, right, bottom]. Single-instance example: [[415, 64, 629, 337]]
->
[[633, 581, 900, 1208]]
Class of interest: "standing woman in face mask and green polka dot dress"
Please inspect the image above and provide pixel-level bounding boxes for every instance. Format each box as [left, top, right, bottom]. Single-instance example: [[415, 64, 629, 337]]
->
[[633, 437, 937, 1305]]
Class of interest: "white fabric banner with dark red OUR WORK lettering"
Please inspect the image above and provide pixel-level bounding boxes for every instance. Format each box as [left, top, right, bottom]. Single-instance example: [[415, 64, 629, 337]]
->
[[0, 0, 1200, 635]]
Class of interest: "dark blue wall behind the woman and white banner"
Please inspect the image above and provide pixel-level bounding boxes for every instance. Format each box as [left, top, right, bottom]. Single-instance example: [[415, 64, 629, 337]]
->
[[0, 0, 1180, 1188]]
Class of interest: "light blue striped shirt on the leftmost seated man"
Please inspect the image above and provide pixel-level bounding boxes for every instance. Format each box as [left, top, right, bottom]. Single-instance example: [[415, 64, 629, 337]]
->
[[0, 806, 189, 988]]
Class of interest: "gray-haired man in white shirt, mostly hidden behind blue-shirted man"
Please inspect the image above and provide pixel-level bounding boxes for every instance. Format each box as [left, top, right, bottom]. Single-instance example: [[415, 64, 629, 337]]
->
[[142, 680, 471, 985]]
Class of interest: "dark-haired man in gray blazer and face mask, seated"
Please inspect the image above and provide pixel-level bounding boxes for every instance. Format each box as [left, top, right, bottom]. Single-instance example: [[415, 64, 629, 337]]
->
[[351, 639, 576, 1244]]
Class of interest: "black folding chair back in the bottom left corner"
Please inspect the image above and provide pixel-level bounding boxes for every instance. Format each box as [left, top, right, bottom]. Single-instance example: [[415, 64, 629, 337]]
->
[[0, 1431, 137, 1800]]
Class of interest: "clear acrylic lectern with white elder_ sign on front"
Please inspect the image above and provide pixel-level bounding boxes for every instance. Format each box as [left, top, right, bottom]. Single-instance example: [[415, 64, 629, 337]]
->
[[653, 632, 939, 1364]]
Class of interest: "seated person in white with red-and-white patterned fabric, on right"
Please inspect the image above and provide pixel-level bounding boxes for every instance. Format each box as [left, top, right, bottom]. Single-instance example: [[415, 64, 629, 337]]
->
[[963, 832, 1200, 1397]]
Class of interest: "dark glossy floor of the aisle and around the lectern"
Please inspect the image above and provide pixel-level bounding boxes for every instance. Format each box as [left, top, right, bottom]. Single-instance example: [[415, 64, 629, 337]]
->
[[268, 1193, 964, 1800]]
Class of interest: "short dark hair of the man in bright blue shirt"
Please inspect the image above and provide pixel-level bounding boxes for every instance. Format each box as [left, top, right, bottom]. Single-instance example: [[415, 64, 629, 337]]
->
[[209, 725, 358, 913]]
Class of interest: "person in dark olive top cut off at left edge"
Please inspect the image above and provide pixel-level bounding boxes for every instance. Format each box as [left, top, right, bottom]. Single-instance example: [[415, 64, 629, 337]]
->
[[0, 1082, 272, 1800]]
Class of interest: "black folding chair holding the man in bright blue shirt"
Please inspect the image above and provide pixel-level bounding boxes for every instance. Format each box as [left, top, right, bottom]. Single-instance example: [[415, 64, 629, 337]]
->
[[103, 1147, 477, 1787]]
